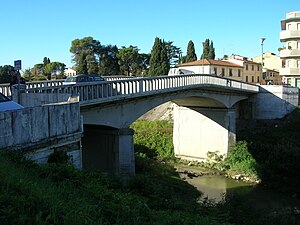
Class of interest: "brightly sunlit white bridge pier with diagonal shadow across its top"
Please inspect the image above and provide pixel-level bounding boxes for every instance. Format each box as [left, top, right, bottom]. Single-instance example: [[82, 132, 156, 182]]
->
[[173, 106, 236, 161]]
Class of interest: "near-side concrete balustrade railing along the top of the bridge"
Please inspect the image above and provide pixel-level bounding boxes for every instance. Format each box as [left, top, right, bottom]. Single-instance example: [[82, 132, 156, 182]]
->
[[22, 75, 259, 103]]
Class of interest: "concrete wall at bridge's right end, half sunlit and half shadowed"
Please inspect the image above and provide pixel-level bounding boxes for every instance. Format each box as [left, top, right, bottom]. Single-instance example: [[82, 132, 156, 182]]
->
[[254, 85, 299, 120]]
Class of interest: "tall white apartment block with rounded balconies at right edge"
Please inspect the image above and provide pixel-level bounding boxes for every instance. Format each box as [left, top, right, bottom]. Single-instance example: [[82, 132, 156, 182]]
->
[[279, 11, 300, 87]]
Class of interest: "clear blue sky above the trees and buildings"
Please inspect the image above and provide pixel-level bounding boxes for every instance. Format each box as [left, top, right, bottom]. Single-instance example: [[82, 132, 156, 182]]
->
[[0, 0, 300, 70]]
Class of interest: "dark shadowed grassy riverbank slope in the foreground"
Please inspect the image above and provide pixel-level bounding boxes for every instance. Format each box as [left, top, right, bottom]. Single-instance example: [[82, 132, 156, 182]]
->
[[0, 149, 229, 225]]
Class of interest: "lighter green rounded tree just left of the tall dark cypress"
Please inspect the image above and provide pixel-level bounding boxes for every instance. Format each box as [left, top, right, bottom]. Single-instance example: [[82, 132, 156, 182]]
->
[[117, 45, 139, 76]]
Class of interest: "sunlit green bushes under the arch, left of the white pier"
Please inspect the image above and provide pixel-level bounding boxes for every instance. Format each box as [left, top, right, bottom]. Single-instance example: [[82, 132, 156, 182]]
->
[[131, 120, 174, 160]]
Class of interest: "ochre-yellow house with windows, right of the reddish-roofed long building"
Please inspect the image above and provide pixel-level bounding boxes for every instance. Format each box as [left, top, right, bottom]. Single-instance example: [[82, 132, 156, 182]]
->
[[225, 54, 262, 84]]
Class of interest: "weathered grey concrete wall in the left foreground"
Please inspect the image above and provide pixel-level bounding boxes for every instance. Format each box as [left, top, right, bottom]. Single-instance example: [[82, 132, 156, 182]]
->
[[0, 103, 82, 167]]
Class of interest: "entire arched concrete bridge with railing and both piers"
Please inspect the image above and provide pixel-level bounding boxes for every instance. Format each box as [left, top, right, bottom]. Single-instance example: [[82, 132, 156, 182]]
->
[[1, 75, 298, 177]]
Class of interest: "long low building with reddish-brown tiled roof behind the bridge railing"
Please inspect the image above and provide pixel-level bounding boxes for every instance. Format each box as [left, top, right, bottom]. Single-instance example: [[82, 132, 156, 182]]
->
[[169, 59, 243, 80]]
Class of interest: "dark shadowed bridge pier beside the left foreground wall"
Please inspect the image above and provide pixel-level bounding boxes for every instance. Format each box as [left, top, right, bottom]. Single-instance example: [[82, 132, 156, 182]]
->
[[82, 125, 135, 179]]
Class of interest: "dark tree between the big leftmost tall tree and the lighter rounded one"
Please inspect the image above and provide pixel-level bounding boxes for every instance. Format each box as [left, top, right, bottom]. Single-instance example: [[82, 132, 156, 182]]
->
[[98, 45, 120, 76]]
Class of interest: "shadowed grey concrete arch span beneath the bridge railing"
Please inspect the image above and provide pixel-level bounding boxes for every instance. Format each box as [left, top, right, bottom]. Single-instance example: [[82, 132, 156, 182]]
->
[[81, 90, 247, 129]]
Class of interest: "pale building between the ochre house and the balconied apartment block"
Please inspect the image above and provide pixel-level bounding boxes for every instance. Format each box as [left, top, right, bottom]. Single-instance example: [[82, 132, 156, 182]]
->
[[252, 52, 282, 85]]
